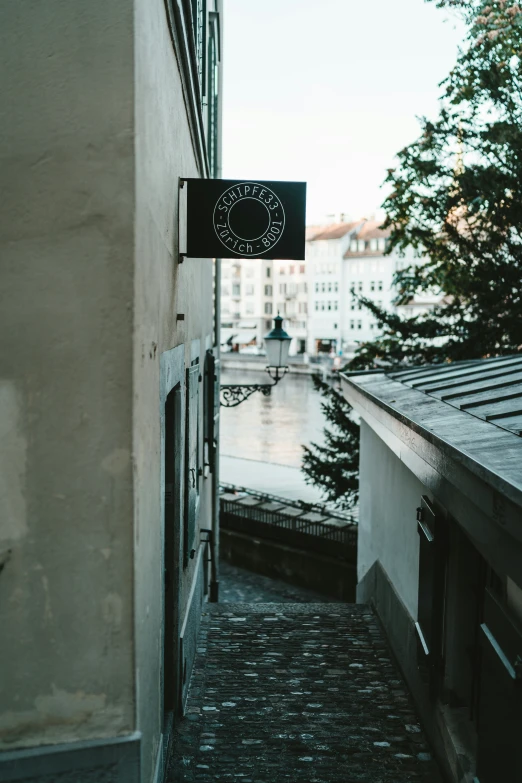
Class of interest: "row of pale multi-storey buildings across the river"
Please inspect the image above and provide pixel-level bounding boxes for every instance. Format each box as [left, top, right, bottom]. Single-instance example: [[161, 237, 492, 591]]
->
[[221, 216, 434, 358]]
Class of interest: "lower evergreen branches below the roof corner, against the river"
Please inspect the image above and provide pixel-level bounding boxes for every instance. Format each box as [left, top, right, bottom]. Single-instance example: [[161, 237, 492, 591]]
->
[[302, 375, 359, 509]]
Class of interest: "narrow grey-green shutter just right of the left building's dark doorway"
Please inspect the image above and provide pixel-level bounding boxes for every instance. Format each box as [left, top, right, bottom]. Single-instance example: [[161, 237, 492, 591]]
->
[[183, 364, 199, 564]]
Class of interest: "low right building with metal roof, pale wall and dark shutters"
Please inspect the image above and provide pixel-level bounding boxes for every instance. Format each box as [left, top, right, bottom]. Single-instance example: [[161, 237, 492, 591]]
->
[[342, 356, 522, 783]]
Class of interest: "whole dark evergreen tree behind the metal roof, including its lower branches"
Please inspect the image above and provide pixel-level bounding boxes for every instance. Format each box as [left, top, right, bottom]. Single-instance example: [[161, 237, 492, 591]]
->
[[303, 0, 522, 507]]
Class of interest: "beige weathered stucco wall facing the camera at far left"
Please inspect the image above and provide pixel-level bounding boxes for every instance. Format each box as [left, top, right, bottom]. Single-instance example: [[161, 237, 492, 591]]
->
[[0, 0, 134, 748]]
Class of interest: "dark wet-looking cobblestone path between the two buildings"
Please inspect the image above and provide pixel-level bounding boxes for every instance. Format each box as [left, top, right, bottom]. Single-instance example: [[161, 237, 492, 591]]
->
[[168, 603, 441, 783]]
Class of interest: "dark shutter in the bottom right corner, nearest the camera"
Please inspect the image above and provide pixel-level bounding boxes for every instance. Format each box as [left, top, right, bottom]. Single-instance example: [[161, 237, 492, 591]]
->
[[477, 590, 522, 783]]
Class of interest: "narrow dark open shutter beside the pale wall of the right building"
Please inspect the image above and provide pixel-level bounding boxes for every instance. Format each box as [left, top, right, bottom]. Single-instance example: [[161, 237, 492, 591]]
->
[[415, 495, 447, 699]]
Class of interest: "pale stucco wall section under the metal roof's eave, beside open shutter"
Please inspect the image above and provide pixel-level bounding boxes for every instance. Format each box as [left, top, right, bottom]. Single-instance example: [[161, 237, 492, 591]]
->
[[357, 421, 428, 619]]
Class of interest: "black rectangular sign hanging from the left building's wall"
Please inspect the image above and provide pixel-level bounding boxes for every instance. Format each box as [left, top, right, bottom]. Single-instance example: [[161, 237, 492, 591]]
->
[[185, 179, 306, 261]]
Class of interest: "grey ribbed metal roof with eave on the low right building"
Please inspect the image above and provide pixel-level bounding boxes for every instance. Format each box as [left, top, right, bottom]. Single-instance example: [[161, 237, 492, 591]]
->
[[340, 355, 522, 524]]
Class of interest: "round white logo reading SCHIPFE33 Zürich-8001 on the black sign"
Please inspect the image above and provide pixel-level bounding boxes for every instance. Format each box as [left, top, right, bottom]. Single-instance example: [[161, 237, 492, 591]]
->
[[214, 182, 285, 258]]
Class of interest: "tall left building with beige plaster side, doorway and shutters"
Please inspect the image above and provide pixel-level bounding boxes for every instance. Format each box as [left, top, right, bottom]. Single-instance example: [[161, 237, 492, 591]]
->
[[0, 0, 222, 783]]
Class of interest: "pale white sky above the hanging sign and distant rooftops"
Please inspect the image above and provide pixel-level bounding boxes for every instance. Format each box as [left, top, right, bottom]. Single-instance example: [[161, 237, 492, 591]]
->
[[219, 0, 464, 223]]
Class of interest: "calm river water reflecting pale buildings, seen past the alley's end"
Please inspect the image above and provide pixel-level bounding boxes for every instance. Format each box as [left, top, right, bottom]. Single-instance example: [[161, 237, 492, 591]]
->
[[221, 370, 325, 468]]
